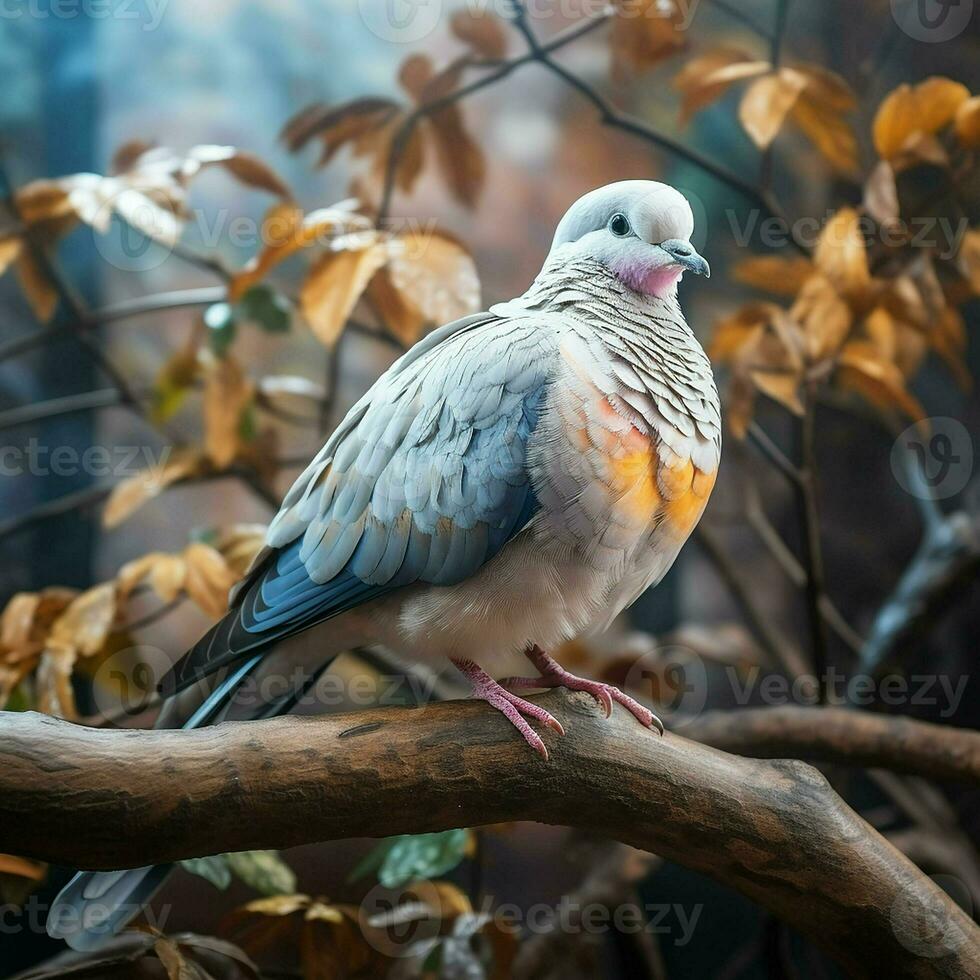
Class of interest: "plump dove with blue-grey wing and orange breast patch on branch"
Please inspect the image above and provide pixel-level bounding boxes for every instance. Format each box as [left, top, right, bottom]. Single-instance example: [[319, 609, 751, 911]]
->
[[48, 180, 721, 949]]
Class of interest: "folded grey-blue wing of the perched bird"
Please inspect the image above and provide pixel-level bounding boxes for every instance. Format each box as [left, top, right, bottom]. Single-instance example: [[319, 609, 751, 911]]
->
[[162, 314, 556, 693]]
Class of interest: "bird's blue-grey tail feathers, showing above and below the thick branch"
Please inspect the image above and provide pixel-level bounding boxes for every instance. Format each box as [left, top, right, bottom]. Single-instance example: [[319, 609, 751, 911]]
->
[[47, 655, 333, 952]]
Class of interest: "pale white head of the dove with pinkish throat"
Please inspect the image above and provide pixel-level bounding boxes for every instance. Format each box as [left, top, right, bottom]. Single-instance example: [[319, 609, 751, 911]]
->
[[549, 180, 711, 297]]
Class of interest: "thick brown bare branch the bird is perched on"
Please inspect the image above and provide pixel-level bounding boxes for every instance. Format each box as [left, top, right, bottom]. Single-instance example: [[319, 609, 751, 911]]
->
[[0, 691, 980, 978]]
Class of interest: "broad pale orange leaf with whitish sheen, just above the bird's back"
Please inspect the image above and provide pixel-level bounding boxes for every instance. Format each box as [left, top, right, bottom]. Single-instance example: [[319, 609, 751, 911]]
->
[[369, 231, 480, 347]]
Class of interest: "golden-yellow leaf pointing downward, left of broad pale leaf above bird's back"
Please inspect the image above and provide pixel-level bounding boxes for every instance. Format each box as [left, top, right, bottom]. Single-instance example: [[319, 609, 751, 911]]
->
[[300, 235, 388, 347]]
